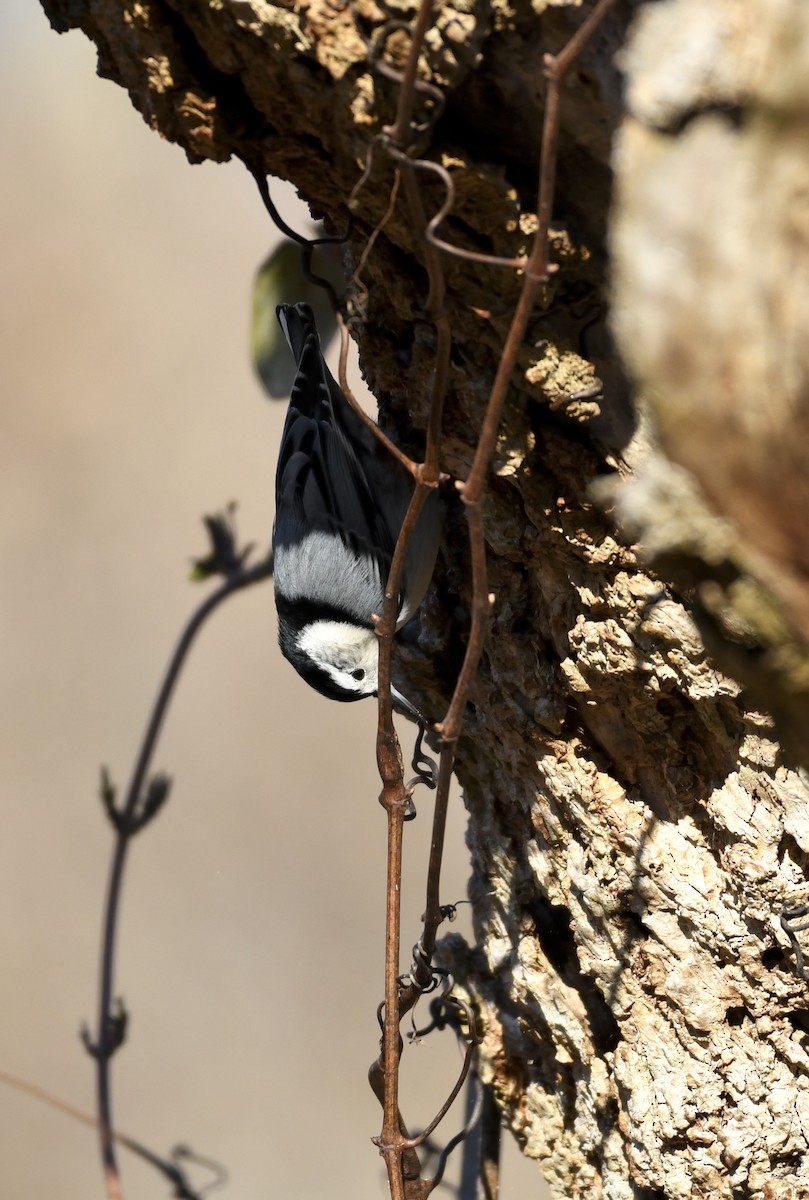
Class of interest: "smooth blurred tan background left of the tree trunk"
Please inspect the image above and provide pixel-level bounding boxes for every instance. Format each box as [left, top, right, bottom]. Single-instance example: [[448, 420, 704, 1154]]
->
[[0, 0, 543, 1200]]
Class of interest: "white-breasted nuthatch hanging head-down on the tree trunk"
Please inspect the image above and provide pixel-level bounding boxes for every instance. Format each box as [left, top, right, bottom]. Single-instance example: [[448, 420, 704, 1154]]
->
[[272, 304, 443, 719]]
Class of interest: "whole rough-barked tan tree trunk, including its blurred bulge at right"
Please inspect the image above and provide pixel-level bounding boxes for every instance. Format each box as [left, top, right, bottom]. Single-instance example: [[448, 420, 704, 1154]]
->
[[43, 0, 809, 1200]]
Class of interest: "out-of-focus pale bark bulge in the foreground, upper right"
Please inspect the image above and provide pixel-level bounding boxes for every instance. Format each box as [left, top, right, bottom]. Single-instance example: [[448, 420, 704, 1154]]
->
[[613, 0, 809, 763]]
